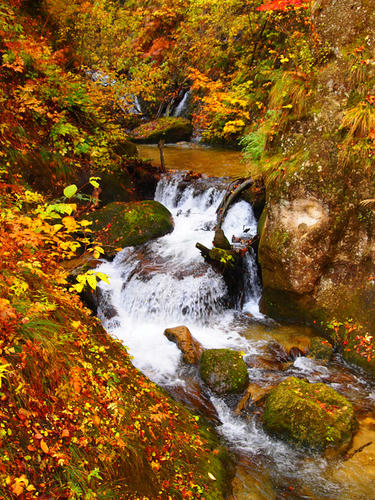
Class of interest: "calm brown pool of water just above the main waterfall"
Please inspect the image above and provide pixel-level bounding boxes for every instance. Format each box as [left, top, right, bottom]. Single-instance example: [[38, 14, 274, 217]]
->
[[137, 142, 248, 177]]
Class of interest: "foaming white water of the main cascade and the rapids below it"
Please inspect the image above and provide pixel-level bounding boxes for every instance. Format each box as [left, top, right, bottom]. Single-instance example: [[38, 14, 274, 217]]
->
[[99, 172, 375, 500]]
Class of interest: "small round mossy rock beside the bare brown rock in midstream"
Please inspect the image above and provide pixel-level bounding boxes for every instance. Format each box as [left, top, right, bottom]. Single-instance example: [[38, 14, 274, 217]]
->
[[200, 349, 249, 394]]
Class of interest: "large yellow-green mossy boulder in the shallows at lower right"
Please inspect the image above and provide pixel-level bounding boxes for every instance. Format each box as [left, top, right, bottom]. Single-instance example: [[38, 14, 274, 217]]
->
[[263, 377, 357, 452]]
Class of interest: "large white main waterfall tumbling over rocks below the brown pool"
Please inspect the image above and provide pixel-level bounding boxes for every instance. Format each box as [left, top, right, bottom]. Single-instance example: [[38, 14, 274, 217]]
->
[[99, 172, 258, 382]]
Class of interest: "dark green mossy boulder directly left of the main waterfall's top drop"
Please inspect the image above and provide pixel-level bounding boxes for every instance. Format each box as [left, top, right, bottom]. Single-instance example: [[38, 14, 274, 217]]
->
[[86, 200, 174, 256]]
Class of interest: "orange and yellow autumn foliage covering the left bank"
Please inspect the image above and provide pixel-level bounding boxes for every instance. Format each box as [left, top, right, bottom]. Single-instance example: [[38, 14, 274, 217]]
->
[[0, 1, 229, 500]]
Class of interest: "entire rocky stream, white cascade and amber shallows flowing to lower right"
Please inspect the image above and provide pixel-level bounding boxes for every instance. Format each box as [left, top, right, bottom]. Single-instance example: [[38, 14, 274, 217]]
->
[[99, 146, 375, 500]]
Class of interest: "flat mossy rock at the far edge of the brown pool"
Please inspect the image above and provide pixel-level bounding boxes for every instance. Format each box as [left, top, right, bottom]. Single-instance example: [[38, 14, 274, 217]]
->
[[131, 116, 193, 144]]
